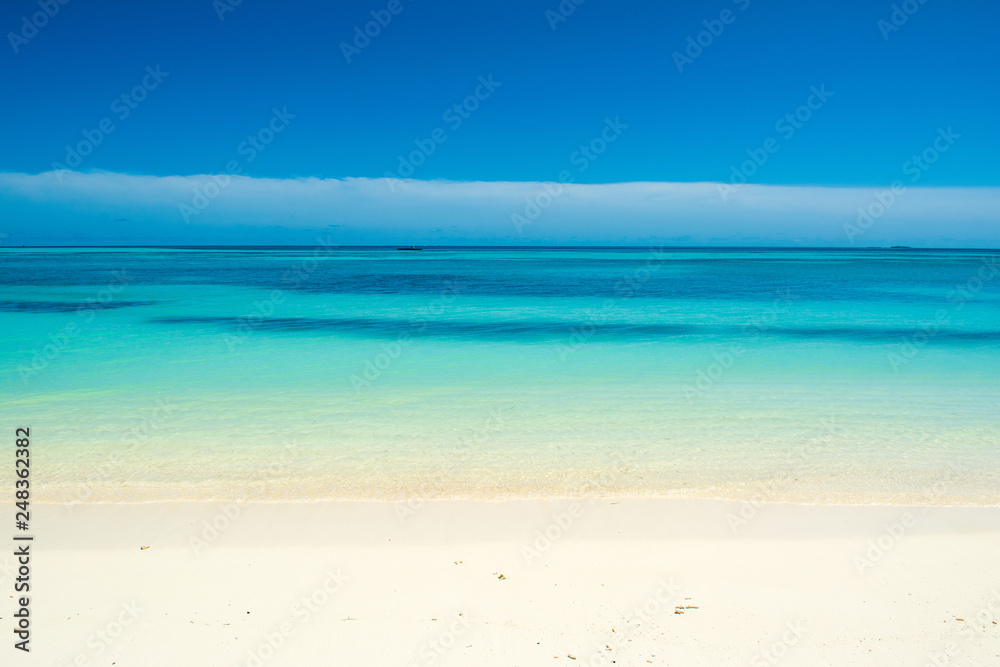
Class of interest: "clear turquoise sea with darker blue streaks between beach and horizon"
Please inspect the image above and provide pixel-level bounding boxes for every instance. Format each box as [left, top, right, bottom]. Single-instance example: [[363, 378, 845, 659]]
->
[[0, 246, 1000, 504]]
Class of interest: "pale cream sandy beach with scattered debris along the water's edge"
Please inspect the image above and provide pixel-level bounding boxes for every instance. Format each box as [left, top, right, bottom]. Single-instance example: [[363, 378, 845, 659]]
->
[[9, 499, 1000, 667]]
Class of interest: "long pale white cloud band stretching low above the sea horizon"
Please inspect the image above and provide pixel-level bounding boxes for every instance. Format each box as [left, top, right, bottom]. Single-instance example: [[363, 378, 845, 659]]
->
[[0, 172, 1000, 247]]
